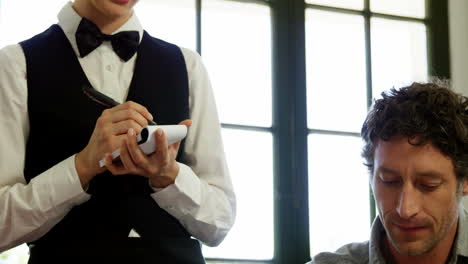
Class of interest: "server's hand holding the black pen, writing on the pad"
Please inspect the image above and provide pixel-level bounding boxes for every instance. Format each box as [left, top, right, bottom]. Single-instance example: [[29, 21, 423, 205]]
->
[[75, 101, 153, 186]]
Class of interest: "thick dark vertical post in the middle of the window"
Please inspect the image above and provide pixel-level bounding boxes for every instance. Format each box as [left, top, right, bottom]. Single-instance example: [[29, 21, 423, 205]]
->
[[272, 0, 310, 263]]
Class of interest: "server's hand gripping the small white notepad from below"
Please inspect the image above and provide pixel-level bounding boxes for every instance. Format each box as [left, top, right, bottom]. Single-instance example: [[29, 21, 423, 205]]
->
[[105, 120, 192, 188]]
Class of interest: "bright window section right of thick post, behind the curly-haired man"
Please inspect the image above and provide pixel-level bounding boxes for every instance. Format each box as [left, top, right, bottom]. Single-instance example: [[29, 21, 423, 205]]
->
[[305, 0, 428, 256]]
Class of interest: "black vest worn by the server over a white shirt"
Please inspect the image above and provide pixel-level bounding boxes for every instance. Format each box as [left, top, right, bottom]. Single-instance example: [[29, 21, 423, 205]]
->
[[20, 25, 203, 263]]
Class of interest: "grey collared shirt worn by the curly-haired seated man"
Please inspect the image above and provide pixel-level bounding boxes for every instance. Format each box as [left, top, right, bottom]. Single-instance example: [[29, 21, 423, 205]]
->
[[309, 206, 468, 264]]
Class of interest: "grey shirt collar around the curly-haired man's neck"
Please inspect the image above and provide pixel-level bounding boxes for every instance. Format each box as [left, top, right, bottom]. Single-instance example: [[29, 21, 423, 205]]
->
[[369, 205, 468, 263]]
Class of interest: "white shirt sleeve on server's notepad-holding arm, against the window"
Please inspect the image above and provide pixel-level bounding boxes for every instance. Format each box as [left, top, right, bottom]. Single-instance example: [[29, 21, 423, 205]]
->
[[152, 48, 236, 246]]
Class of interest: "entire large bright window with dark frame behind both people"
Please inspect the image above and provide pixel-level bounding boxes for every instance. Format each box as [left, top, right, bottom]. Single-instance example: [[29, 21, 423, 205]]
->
[[0, 0, 449, 264]]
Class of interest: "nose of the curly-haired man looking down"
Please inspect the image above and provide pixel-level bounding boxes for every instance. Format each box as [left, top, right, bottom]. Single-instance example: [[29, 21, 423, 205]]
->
[[396, 184, 421, 219]]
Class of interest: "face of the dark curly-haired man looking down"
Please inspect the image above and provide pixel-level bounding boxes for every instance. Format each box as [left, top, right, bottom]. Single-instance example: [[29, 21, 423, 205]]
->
[[371, 137, 468, 256]]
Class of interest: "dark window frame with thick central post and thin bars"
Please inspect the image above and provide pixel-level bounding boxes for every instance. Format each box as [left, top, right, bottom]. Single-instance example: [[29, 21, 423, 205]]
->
[[204, 0, 450, 263]]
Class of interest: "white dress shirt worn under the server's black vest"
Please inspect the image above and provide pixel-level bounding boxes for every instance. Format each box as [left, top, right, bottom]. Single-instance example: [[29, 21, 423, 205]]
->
[[0, 2, 236, 252]]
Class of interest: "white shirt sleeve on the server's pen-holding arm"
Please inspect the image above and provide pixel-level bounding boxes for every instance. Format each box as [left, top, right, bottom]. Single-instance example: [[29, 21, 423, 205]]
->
[[0, 45, 90, 252]]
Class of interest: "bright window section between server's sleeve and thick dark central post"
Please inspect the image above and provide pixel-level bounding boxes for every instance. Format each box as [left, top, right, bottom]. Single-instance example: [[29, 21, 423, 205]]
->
[[201, 0, 274, 260]]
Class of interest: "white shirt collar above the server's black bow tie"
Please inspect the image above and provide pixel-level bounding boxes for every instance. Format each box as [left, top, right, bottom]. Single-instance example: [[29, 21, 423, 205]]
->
[[57, 2, 143, 51]]
